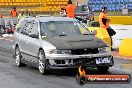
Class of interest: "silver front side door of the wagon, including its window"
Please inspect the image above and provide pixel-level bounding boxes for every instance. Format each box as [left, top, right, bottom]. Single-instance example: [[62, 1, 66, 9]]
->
[[27, 20, 41, 63]]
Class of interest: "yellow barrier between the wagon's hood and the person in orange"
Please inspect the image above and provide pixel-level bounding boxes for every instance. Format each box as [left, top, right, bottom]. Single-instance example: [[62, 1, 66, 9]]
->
[[88, 27, 111, 49]]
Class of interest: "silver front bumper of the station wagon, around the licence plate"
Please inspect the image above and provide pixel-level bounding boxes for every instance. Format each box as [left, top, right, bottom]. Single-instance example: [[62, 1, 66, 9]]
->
[[46, 52, 114, 69]]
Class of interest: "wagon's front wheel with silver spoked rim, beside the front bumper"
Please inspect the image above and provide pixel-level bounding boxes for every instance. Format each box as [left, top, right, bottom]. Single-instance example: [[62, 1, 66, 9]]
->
[[38, 50, 46, 75]]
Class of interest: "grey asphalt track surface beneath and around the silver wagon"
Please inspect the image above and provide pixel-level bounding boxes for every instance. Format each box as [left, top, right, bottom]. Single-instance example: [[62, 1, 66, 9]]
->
[[0, 39, 132, 88]]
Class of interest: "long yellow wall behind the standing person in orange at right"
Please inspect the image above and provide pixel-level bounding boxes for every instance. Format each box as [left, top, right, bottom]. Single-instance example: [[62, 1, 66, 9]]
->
[[95, 16, 132, 25]]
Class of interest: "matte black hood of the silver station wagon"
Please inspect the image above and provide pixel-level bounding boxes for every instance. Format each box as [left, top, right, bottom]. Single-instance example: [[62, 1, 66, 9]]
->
[[45, 35, 107, 49]]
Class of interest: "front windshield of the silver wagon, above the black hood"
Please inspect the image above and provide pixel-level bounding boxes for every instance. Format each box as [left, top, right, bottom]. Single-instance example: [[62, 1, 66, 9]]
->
[[41, 21, 90, 37]]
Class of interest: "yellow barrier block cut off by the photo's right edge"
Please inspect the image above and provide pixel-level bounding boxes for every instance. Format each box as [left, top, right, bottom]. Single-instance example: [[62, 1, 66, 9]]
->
[[119, 38, 132, 56]]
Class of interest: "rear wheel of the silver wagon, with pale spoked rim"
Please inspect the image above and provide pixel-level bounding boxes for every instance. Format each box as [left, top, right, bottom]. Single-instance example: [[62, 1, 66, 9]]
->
[[15, 47, 25, 67]]
